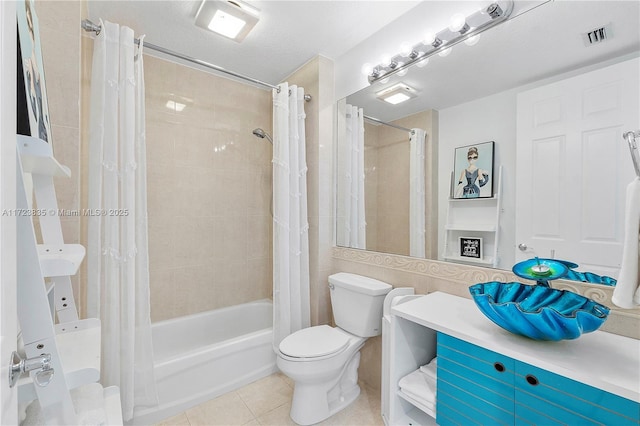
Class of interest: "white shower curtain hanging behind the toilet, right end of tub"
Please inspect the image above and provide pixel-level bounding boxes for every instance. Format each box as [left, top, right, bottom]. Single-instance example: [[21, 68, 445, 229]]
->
[[273, 83, 311, 351]]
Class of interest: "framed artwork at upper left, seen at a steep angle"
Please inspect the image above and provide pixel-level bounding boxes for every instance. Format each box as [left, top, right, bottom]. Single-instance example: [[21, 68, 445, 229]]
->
[[16, 0, 51, 142]]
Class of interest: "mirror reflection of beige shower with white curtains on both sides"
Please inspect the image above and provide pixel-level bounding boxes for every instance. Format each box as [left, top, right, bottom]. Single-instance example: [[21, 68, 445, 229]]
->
[[336, 99, 437, 258]]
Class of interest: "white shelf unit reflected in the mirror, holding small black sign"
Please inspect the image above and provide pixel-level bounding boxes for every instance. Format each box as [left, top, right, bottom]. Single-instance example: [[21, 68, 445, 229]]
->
[[442, 166, 502, 268]]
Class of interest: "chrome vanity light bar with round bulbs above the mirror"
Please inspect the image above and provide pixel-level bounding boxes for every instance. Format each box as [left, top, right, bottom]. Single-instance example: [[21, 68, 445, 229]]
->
[[363, 0, 514, 84]]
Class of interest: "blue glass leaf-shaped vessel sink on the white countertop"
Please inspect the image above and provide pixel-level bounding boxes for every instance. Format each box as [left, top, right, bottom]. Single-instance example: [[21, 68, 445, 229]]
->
[[469, 281, 609, 340]]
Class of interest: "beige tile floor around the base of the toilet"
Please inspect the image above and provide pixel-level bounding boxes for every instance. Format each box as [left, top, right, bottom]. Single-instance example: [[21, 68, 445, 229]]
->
[[158, 373, 384, 426]]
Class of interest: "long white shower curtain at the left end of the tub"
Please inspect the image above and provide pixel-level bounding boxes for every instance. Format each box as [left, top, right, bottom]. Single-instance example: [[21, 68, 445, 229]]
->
[[86, 22, 157, 420]]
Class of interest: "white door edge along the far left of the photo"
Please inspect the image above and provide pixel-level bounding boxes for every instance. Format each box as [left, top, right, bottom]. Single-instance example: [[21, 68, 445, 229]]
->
[[0, 1, 18, 425]]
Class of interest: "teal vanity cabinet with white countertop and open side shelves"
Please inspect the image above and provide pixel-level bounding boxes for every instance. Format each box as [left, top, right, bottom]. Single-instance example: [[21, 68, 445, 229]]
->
[[383, 292, 640, 426]]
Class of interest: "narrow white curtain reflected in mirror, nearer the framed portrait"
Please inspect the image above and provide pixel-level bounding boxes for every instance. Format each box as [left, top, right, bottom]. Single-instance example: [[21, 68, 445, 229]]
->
[[409, 129, 427, 258]]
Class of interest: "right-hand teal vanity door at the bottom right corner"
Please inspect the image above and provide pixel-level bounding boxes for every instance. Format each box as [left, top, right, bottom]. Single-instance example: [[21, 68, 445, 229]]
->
[[515, 361, 640, 426]]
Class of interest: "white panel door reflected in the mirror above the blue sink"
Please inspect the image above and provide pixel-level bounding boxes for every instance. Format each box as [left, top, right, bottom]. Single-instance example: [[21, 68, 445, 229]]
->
[[515, 58, 640, 277]]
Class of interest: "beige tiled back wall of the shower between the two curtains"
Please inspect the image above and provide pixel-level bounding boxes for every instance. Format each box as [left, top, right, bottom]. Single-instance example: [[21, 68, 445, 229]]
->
[[145, 56, 272, 321]]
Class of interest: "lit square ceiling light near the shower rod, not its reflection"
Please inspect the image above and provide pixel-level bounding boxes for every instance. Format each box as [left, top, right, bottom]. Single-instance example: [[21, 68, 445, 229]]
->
[[196, 0, 260, 42]]
